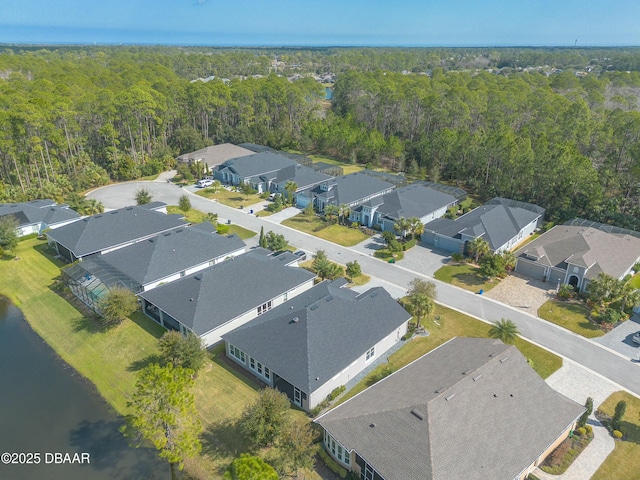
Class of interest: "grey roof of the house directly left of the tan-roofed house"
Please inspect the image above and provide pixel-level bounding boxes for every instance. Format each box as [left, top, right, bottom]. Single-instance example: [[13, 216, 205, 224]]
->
[[425, 197, 544, 250]]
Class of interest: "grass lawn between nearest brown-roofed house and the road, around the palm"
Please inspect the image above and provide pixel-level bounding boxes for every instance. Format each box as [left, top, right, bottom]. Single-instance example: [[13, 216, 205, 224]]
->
[[339, 305, 562, 403]]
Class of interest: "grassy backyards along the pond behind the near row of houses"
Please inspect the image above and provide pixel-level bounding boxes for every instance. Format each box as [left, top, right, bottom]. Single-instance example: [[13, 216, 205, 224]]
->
[[0, 239, 312, 479]]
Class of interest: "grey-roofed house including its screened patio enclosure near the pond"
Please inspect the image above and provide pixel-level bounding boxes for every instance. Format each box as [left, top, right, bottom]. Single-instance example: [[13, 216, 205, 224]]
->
[[61, 223, 246, 309]]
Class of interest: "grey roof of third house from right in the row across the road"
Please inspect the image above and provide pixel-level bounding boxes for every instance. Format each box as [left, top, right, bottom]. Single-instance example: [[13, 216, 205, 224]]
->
[[378, 184, 458, 220]]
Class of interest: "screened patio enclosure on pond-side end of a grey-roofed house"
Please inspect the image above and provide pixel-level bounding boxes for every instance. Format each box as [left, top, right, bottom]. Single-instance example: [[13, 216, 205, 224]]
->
[[61, 255, 143, 313]]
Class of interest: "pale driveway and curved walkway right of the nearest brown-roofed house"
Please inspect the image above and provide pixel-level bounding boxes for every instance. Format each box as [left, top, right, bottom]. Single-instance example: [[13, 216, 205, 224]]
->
[[534, 358, 620, 480]]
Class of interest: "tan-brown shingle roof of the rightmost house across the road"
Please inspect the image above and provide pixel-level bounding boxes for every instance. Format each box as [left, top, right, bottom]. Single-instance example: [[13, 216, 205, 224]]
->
[[515, 225, 640, 279]]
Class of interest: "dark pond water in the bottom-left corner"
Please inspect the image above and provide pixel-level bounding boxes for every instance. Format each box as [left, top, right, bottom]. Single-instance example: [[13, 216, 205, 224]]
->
[[0, 297, 171, 480]]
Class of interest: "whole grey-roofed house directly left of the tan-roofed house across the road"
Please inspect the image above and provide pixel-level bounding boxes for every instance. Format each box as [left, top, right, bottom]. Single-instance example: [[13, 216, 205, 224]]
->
[[422, 197, 544, 253]]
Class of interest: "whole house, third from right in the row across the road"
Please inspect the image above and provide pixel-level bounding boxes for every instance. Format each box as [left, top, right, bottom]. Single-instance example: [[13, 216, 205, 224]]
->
[[364, 183, 458, 231]]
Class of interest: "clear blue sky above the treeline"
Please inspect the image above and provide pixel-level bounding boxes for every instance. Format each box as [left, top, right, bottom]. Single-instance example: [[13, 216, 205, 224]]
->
[[0, 0, 640, 47]]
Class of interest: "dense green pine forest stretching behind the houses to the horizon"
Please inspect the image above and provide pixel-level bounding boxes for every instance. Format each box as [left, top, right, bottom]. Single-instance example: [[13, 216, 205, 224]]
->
[[0, 47, 640, 230]]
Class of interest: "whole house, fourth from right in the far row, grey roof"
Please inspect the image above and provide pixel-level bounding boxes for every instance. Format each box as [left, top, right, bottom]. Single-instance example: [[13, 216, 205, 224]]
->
[[296, 171, 394, 218]]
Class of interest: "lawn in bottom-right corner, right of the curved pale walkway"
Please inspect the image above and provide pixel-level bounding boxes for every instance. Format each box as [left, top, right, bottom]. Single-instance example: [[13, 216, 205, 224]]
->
[[591, 392, 640, 480]]
